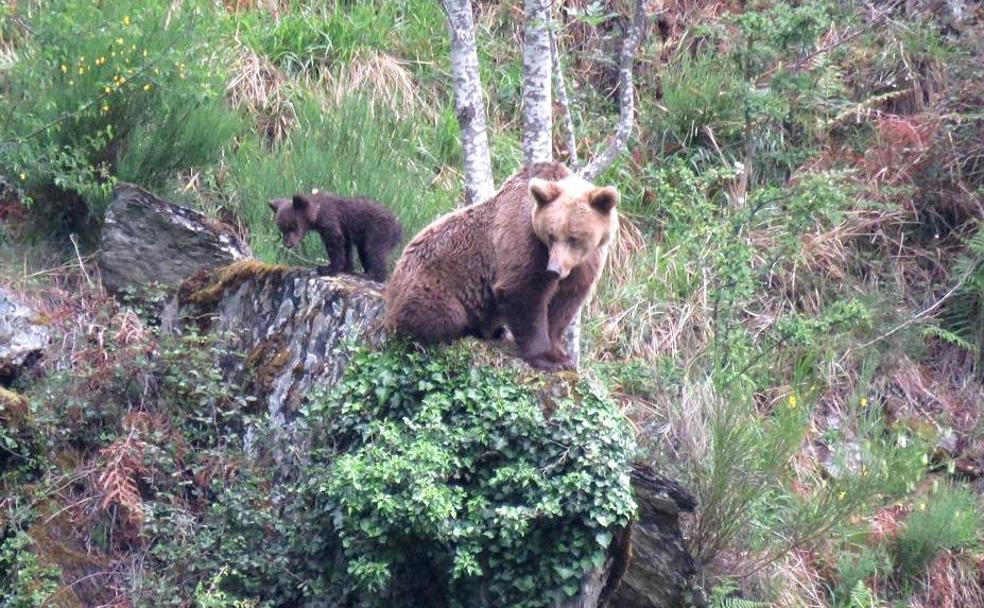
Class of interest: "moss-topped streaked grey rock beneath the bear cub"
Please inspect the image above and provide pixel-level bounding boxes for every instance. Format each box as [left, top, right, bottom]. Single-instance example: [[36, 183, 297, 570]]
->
[[164, 261, 383, 423]]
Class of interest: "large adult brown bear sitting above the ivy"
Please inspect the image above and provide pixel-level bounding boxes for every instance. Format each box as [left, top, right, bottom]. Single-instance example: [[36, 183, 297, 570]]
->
[[384, 163, 619, 371]]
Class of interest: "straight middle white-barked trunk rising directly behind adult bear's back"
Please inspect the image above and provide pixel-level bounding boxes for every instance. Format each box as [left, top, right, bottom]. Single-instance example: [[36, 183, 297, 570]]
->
[[523, 0, 553, 163]]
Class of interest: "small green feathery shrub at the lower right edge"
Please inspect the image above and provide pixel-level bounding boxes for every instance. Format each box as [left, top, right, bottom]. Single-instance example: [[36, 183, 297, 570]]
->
[[891, 485, 981, 584]]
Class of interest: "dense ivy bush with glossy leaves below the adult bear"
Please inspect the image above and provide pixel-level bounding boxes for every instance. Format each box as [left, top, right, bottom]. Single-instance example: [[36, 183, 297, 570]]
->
[[309, 346, 634, 607]]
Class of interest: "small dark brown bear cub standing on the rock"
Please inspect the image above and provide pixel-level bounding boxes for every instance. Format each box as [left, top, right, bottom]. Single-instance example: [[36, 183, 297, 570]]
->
[[269, 192, 403, 281]]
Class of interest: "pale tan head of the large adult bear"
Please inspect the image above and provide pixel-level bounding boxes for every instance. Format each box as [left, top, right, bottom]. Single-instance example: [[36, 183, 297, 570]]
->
[[530, 175, 619, 279]]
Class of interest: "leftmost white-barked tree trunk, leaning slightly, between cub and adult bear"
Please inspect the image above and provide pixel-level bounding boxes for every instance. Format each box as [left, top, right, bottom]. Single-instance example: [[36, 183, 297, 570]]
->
[[441, 0, 495, 204]]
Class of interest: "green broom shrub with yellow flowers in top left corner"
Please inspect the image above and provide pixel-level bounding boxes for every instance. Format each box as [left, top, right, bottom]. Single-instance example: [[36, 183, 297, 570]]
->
[[0, 0, 238, 221]]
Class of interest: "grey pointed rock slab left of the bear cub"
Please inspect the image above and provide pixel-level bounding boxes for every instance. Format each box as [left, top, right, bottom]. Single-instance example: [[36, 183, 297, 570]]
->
[[99, 183, 252, 291]]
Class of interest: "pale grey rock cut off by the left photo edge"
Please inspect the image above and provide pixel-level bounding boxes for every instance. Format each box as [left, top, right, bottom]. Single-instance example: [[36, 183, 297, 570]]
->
[[0, 289, 51, 380]]
